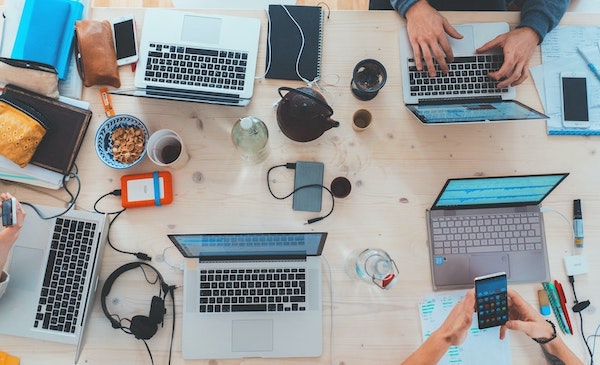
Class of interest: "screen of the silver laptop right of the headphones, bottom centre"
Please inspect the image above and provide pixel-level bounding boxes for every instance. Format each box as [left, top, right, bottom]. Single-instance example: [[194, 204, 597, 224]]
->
[[168, 232, 327, 259]]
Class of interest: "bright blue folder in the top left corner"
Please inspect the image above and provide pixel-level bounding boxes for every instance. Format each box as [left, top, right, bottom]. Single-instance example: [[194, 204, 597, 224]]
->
[[11, 0, 83, 79]]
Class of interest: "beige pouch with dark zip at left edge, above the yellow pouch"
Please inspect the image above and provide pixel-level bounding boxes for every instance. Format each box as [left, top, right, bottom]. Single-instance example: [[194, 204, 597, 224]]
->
[[0, 57, 59, 99]]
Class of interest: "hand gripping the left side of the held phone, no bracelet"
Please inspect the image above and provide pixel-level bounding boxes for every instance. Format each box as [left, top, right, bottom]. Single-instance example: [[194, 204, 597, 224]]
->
[[436, 290, 475, 346]]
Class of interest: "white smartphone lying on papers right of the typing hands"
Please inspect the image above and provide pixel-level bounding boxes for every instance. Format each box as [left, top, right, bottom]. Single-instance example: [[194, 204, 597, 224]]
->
[[560, 72, 590, 128]]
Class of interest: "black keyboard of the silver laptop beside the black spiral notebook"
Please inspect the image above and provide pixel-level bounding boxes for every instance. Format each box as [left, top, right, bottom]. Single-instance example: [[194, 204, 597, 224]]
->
[[144, 43, 248, 90]]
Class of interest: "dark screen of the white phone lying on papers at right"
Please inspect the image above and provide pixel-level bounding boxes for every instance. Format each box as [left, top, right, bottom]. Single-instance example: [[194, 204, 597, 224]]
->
[[562, 77, 589, 122]]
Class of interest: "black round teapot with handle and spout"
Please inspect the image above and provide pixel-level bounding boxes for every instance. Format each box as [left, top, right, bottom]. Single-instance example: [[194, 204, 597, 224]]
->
[[277, 86, 340, 142]]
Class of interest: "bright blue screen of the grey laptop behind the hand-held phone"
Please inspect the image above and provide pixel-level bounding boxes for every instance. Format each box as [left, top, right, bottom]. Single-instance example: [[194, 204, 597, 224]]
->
[[432, 173, 568, 209]]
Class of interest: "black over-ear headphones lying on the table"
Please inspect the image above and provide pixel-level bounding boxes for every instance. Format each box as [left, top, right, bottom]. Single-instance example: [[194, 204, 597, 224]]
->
[[100, 262, 175, 340]]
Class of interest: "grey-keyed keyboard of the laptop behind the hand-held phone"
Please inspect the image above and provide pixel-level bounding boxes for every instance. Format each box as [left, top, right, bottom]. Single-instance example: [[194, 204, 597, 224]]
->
[[432, 212, 543, 255]]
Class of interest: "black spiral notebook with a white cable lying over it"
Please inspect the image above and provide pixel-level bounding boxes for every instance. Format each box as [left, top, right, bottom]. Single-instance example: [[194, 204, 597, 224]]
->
[[265, 5, 323, 81]]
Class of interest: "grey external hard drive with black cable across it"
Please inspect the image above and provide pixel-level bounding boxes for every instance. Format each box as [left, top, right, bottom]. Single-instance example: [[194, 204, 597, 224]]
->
[[292, 161, 325, 212]]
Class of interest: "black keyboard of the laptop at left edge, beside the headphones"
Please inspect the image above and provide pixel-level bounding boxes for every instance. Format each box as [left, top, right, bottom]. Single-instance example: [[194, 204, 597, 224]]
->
[[33, 218, 96, 333]]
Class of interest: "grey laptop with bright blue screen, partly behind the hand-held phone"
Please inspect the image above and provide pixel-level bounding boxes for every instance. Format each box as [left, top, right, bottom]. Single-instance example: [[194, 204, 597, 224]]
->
[[426, 173, 568, 290]]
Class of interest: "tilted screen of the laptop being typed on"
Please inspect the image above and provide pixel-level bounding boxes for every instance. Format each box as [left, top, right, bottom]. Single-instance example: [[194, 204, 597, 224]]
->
[[407, 100, 548, 124]]
